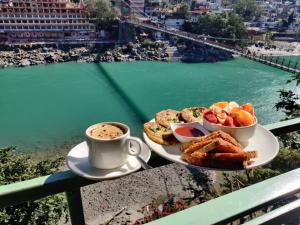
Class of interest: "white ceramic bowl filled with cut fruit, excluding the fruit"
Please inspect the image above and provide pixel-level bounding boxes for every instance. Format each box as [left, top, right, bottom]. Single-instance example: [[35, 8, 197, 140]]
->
[[203, 118, 257, 146]]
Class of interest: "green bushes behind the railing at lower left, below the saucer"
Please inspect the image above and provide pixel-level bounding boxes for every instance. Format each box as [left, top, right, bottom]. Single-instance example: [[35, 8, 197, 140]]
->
[[0, 147, 67, 225]]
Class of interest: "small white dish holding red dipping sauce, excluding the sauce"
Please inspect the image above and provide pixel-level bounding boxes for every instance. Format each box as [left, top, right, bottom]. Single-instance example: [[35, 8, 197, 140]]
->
[[170, 122, 209, 143]]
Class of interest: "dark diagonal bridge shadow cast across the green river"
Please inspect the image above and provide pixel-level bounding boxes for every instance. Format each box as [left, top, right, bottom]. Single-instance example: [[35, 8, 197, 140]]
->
[[95, 63, 149, 124]]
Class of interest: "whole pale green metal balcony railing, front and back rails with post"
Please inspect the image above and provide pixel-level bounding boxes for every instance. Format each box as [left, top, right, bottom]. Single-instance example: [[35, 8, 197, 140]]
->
[[0, 118, 300, 225]]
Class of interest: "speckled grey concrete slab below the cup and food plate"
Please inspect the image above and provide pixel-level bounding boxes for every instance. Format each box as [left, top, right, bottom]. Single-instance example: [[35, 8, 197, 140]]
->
[[81, 164, 215, 225]]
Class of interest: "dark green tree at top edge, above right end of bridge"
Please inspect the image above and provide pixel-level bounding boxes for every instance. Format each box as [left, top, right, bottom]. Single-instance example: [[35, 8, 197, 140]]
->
[[233, 0, 262, 21]]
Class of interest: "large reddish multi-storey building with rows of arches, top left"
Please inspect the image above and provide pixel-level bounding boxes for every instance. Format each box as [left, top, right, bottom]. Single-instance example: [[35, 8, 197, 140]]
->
[[0, 0, 96, 44]]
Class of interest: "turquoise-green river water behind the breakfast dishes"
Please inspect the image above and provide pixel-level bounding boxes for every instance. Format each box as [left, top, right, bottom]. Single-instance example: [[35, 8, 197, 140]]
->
[[0, 58, 290, 152]]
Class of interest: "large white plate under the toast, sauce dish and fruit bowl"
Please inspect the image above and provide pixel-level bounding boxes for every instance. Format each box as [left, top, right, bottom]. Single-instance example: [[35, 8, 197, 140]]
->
[[143, 124, 279, 170]]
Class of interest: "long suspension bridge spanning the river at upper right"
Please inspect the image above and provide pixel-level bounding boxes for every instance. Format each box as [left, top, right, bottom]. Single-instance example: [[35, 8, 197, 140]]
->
[[123, 1, 300, 73]]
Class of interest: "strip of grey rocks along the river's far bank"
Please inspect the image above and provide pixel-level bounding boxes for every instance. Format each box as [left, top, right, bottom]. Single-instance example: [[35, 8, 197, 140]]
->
[[0, 40, 233, 68]]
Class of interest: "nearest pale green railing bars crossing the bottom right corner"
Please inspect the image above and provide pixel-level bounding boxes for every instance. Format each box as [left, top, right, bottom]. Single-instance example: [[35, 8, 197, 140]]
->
[[149, 169, 300, 225]]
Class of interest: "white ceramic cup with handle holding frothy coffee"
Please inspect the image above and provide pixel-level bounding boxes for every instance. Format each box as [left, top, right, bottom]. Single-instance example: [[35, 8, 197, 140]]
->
[[85, 122, 143, 169]]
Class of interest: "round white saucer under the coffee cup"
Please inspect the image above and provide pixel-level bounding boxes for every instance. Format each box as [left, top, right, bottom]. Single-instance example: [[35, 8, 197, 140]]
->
[[66, 141, 151, 180]]
